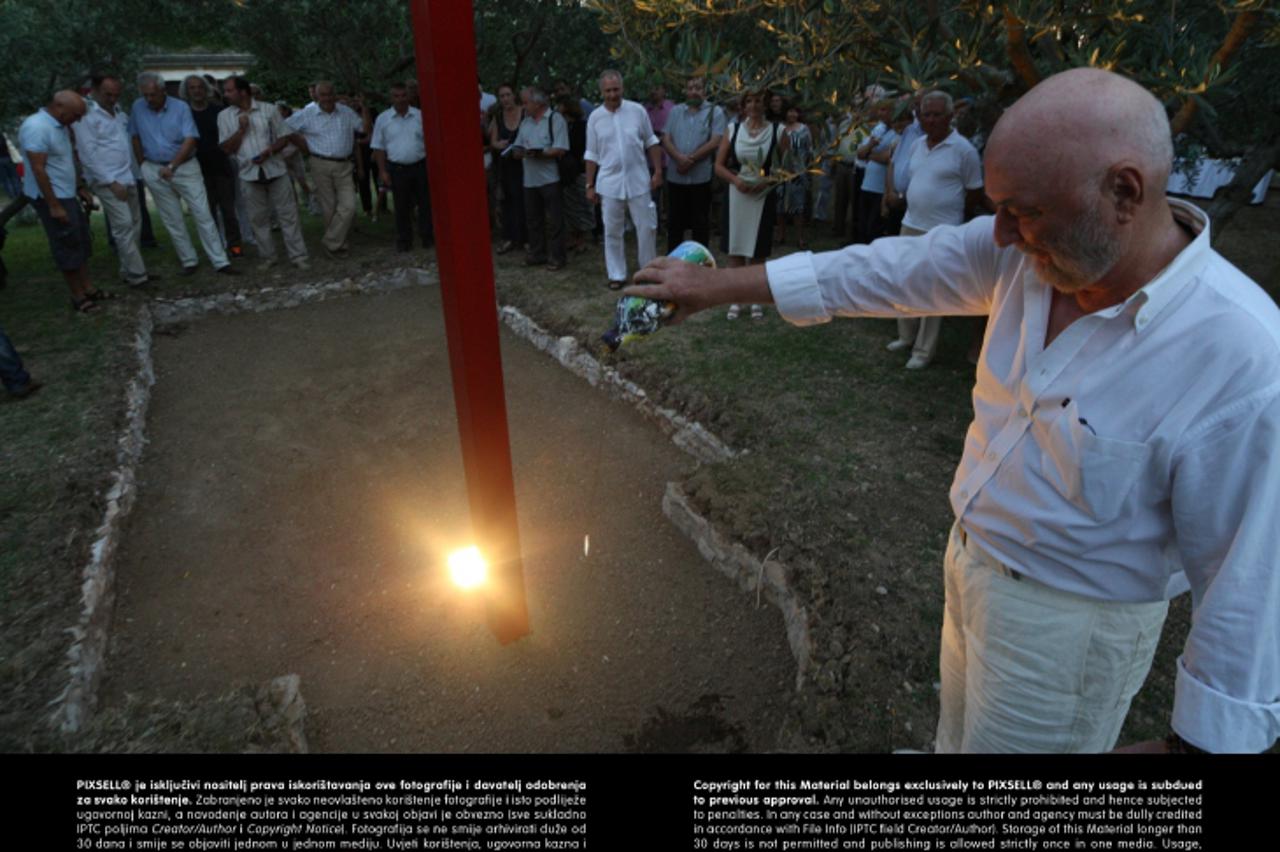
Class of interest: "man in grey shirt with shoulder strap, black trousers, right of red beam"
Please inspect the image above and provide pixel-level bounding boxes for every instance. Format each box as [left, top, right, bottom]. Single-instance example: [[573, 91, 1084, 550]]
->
[[506, 87, 568, 272]]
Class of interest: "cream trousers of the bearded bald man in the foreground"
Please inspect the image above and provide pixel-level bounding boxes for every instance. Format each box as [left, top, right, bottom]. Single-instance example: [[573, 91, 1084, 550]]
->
[[937, 523, 1169, 753]]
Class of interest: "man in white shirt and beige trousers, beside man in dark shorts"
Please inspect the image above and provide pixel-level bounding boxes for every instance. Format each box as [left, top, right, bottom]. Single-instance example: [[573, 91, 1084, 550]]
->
[[72, 75, 159, 287]]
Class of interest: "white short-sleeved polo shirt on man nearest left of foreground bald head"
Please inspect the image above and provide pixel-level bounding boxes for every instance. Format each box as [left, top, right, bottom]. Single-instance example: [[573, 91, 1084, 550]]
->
[[902, 130, 982, 230]]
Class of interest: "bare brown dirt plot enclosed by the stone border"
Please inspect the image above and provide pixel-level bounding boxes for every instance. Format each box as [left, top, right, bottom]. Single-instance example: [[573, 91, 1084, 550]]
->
[[102, 287, 795, 752]]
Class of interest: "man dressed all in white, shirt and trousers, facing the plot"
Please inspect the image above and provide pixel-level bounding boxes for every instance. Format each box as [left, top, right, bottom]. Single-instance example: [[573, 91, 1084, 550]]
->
[[582, 70, 662, 289]]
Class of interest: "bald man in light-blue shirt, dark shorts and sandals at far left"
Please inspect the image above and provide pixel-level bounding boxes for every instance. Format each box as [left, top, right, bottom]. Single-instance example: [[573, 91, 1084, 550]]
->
[[18, 91, 109, 313]]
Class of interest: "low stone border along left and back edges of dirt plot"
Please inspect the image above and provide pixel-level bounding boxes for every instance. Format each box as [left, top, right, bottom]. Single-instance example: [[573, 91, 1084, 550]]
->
[[49, 267, 435, 731]]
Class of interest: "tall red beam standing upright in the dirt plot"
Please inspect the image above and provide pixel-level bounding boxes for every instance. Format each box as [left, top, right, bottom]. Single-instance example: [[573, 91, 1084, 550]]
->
[[410, 0, 529, 645]]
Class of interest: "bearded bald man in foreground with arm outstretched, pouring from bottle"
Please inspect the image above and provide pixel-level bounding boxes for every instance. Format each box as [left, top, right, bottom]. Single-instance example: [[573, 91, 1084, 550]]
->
[[627, 69, 1280, 752]]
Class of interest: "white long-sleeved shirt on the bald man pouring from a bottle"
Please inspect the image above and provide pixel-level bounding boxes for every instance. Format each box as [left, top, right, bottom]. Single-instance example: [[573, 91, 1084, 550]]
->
[[767, 195, 1280, 751]]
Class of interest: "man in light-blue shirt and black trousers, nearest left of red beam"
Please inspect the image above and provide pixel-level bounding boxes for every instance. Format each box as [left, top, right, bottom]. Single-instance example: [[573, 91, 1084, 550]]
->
[[370, 83, 435, 252]]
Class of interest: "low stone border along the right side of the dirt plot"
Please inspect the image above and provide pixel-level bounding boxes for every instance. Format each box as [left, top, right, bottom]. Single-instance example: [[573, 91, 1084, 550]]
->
[[499, 301, 813, 692]]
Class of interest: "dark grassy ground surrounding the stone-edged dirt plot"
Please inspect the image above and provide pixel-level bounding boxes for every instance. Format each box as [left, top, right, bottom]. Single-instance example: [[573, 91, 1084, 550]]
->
[[0, 180, 1280, 751]]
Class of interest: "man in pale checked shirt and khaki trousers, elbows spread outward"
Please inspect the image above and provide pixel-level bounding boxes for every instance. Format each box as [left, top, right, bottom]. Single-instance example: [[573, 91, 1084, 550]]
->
[[284, 81, 370, 258]]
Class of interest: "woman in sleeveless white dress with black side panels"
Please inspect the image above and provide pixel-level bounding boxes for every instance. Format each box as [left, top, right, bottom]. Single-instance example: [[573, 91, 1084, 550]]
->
[[716, 92, 787, 320]]
